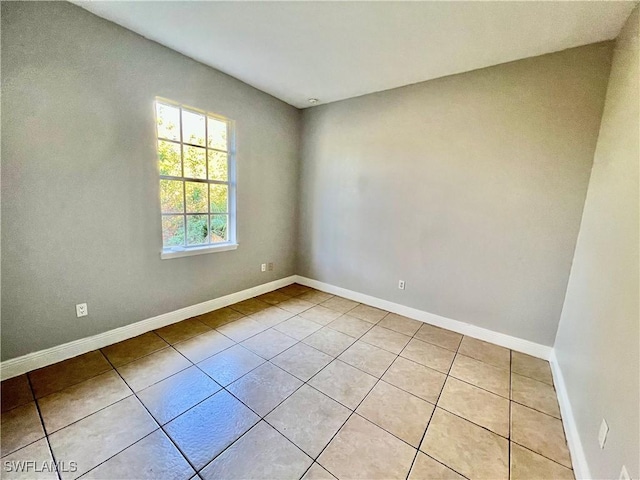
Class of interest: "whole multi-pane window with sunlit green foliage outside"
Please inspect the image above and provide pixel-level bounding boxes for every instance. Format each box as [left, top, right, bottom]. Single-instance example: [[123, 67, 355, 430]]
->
[[155, 99, 237, 258]]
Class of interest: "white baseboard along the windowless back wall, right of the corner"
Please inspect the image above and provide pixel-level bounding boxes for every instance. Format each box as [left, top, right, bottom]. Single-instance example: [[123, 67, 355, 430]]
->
[[296, 275, 553, 360]]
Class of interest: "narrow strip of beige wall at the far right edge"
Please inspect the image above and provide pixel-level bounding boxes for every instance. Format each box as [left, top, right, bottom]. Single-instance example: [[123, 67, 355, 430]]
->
[[555, 8, 640, 478]]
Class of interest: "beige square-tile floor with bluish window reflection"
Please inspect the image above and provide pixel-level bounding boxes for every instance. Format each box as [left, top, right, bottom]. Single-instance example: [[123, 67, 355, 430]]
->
[[1, 284, 573, 480]]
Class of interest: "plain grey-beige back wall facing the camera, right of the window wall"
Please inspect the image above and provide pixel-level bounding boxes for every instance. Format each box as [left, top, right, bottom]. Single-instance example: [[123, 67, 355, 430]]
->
[[298, 44, 612, 345]]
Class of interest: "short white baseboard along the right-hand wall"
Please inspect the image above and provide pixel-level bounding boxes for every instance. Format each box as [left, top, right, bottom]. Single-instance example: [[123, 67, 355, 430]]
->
[[549, 350, 591, 480]]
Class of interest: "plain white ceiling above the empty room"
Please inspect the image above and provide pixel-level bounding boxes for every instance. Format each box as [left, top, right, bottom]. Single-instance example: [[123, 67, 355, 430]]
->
[[74, 0, 635, 108]]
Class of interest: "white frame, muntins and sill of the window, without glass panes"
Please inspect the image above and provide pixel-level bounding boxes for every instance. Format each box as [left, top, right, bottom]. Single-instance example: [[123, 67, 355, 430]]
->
[[153, 97, 238, 260]]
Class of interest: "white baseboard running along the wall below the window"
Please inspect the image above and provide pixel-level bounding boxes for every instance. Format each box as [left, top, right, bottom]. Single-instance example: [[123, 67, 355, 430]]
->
[[0, 275, 296, 380]]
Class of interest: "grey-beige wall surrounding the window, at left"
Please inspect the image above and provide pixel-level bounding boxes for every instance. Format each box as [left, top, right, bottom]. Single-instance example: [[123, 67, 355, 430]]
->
[[2, 2, 300, 359]]
